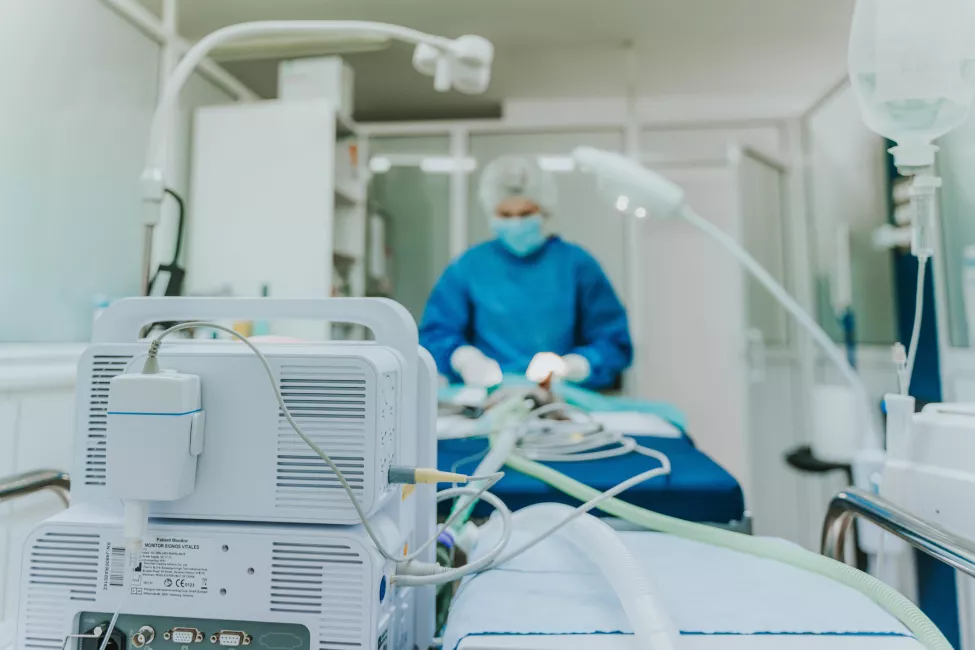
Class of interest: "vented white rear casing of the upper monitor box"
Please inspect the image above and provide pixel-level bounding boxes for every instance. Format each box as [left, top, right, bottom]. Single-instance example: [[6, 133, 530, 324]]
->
[[72, 339, 404, 524]]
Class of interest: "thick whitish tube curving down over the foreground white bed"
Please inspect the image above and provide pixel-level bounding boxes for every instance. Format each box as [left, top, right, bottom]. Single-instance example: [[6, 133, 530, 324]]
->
[[512, 503, 680, 650]]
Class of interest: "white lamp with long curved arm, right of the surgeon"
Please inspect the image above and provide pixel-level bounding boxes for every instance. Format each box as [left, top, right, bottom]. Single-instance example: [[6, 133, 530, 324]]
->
[[572, 147, 883, 449]]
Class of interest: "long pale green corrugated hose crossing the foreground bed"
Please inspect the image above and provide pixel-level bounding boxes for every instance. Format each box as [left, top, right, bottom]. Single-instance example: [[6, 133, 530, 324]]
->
[[506, 455, 952, 650]]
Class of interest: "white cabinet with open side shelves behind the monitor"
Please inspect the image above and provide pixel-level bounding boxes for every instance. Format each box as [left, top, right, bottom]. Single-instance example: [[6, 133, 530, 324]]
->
[[187, 99, 368, 339]]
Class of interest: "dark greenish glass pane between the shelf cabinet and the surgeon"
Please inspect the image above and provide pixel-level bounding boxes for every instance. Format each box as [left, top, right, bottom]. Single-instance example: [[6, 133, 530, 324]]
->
[[369, 135, 450, 322]]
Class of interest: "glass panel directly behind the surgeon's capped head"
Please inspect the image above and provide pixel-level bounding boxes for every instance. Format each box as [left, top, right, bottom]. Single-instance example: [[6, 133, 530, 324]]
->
[[468, 131, 625, 300]]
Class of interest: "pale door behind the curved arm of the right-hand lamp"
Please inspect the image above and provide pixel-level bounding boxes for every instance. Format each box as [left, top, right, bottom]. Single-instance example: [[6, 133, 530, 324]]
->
[[639, 150, 803, 541]]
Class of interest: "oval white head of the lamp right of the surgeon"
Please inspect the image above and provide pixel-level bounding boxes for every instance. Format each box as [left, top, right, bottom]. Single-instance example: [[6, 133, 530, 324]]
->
[[572, 147, 684, 219]]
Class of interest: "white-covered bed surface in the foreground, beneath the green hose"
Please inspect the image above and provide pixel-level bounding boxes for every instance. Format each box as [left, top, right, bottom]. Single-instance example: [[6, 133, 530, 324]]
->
[[443, 531, 922, 650]]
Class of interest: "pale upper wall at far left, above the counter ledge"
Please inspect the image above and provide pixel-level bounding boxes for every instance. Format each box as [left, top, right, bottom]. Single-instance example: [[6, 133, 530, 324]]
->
[[0, 0, 236, 342]]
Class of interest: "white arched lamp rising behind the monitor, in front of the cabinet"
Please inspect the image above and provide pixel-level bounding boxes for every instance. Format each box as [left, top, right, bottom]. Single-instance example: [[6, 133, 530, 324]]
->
[[142, 20, 494, 295]]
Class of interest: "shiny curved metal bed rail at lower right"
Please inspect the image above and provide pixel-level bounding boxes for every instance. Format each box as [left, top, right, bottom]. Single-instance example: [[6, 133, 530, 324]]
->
[[822, 488, 975, 577]]
